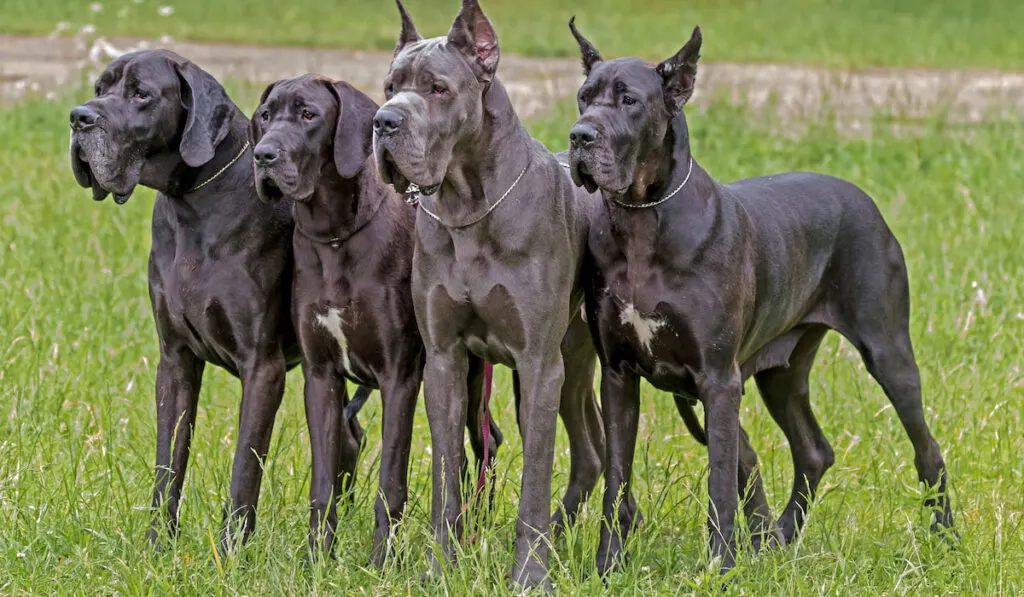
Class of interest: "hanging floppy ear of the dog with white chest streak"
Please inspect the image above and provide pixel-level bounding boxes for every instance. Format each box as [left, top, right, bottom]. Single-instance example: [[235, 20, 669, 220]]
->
[[324, 81, 379, 178]]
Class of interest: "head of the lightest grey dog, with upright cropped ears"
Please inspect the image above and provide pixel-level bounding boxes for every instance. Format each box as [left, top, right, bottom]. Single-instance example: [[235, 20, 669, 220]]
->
[[374, 0, 499, 195]]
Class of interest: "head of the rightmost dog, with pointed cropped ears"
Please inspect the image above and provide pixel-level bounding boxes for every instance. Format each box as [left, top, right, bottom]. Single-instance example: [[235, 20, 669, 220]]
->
[[569, 20, 701, 197]]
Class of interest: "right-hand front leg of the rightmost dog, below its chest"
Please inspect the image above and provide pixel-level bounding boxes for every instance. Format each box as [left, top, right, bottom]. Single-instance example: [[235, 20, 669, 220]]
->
[[698, 371, 742, 572]]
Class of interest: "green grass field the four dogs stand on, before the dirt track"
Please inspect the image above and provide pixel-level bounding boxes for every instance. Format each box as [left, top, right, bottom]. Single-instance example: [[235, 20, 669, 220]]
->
[[0, 87, 1024, 595]]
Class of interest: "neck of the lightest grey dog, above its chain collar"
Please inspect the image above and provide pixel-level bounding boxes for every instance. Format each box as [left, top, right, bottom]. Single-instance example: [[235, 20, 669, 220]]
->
[[431, 77, 531, 227]]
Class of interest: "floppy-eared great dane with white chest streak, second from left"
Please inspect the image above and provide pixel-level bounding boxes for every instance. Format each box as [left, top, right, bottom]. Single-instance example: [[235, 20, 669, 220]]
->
[[252, 75, 502, 565]]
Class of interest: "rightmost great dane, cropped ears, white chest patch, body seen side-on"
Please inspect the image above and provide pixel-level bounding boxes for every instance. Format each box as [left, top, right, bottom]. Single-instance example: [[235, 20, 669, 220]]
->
[[568, 22, 955, 573]]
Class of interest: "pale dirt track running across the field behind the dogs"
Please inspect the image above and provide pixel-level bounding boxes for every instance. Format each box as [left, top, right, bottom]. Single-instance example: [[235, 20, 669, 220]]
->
[[0, 36, 1024, 131]]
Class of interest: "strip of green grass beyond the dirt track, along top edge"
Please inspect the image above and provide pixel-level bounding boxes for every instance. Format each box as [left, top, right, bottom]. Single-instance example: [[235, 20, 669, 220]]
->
[[6, 0, 1024, 69]]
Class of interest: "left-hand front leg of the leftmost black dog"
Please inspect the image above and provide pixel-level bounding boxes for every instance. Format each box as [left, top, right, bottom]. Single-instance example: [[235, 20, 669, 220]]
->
[[146, 346, 206, 547]]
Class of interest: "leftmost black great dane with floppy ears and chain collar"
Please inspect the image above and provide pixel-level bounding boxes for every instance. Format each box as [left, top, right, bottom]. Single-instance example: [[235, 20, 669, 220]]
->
[[71, 50, 300, 548]]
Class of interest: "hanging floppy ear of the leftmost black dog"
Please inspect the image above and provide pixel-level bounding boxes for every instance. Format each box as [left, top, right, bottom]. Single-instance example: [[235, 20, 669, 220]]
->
[[174, 61, 234, 168]]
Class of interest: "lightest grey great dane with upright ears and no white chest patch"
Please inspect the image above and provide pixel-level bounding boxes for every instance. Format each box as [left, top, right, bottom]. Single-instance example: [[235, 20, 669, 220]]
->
[[374, 0, 604, 588]]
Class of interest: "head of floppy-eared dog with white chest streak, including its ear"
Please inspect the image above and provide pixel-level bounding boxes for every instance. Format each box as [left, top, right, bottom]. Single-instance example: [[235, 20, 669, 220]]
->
[[250, 75, 377, 202]]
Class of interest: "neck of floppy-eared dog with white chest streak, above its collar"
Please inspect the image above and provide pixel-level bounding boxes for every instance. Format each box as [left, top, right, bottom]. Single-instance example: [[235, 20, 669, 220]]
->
[[293, 156, 393, 247]]
